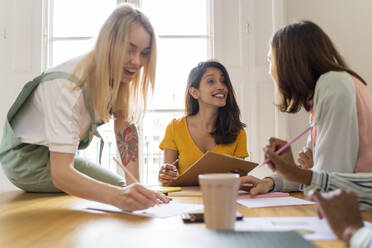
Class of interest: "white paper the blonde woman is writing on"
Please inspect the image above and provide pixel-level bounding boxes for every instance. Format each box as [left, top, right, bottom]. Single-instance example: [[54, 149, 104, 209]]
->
[[87, 202, 204, 218]]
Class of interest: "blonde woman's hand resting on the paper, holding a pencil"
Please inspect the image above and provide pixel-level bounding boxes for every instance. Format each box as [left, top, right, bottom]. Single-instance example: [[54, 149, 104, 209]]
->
[[113, 183, 172, 211]]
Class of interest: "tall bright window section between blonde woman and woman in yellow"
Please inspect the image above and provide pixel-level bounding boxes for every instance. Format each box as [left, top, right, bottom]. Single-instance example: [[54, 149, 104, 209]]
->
[[141, 0, 211, 184]]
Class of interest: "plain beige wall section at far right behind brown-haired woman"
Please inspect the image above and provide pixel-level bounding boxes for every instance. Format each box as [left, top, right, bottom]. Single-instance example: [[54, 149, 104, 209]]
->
[[286, 0, 372, 155]]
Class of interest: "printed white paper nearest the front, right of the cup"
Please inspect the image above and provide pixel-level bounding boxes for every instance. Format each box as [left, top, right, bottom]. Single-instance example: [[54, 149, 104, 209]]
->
[[235, 217, 337, 240]]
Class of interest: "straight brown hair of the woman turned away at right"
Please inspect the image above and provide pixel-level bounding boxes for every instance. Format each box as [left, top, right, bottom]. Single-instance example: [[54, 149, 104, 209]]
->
[[271, 21, 366, 113]]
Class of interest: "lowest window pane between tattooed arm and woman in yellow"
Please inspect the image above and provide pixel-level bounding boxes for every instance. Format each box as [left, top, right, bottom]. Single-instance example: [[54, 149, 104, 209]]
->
[[142, 112, 184, 185]]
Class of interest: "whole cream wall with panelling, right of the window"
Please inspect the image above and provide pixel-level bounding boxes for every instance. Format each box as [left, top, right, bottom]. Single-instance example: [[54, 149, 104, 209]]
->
[[215, 0, 372, 167]]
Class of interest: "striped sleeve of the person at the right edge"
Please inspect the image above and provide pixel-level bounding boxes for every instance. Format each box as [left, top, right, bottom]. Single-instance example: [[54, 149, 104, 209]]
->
[[302, 171, 372, 211]]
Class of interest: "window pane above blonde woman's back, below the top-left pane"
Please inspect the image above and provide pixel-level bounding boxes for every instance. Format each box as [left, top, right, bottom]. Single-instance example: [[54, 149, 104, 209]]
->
[[52, 39, 95, 66]]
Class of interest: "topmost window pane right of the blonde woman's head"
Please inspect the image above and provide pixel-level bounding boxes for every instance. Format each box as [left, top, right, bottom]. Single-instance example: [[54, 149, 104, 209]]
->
[[141, 0, 207, 35]]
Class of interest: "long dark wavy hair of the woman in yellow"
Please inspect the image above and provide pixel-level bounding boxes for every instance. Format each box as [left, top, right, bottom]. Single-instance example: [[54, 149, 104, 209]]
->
[[185, 61, 245, 144]]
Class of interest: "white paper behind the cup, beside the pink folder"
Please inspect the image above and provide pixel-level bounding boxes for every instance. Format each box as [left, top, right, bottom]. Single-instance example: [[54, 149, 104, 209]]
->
[[237, 196, 314, 208]]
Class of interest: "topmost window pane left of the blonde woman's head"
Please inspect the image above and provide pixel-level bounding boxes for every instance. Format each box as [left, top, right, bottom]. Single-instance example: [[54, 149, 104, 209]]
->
[[52, 0, 116, 37]]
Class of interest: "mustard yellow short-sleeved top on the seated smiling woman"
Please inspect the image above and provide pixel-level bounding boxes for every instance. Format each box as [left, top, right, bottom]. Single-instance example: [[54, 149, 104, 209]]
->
[[159, 117, 248, 174]]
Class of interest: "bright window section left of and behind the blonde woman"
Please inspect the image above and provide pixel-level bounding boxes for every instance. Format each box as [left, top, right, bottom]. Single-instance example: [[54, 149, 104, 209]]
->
[[46, 0, 117, 172]]
